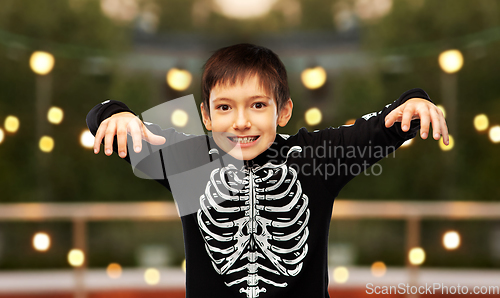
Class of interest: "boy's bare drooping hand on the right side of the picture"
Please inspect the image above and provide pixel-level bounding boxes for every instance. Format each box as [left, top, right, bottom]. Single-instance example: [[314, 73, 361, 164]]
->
[[385, 98, 450, 145]]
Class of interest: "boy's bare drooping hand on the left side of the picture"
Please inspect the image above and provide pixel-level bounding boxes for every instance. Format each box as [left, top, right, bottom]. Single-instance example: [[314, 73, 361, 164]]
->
[[94, 112, 166, 158]]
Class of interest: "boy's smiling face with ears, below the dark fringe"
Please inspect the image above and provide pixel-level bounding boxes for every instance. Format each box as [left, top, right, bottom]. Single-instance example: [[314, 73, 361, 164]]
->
[[201, 76, 293, 160]]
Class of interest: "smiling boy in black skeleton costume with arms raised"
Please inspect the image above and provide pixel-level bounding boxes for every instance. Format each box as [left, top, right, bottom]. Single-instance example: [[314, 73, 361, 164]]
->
[[87, 44, 448, 297]]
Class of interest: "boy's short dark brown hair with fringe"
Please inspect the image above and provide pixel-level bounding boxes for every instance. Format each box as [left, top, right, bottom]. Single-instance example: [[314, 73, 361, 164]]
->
[[201, 43, 290, 113]]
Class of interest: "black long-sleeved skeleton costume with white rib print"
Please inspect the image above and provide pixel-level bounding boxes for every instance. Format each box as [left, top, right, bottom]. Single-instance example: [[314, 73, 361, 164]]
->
[[87, 88, 430, 298]]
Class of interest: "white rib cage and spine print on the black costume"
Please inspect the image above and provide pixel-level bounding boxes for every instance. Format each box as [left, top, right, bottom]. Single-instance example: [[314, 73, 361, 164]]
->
[[197, 146, 310, 298]]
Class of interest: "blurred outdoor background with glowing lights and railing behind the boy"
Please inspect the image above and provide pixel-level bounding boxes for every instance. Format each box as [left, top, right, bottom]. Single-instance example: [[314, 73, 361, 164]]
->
[[0, 0, 500, 297]]
